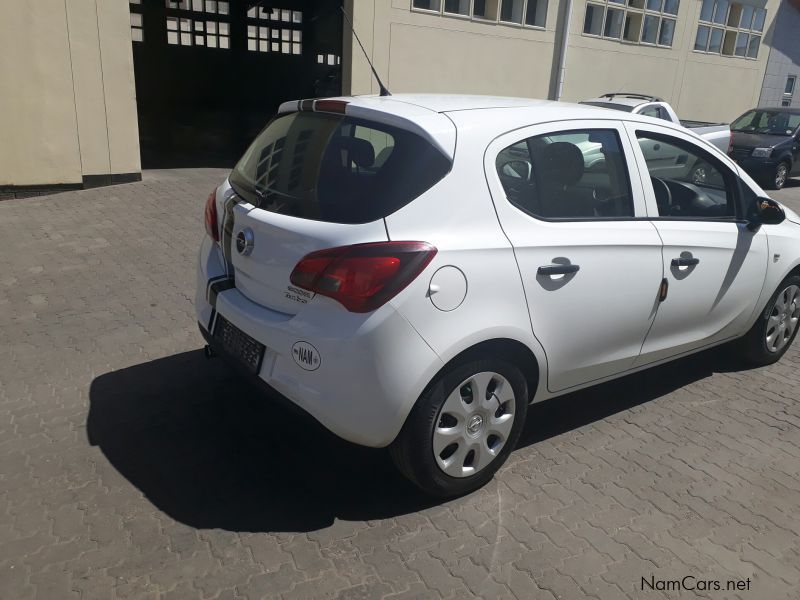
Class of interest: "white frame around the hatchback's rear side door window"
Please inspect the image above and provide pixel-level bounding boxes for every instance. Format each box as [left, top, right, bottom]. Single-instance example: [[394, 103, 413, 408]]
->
[[484, 119, 649, 225]]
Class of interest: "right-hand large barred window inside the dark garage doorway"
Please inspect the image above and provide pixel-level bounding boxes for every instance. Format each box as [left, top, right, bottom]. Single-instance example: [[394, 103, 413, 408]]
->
[[247, 6, 303, 54]]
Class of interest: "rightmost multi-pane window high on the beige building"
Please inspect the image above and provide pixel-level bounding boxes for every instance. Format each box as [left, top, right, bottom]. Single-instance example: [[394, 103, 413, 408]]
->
[[694, 0, 767, 58]]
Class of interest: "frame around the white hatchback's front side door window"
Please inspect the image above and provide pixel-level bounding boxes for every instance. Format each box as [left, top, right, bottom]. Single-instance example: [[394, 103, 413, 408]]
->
[[625, 121, 748, 224]]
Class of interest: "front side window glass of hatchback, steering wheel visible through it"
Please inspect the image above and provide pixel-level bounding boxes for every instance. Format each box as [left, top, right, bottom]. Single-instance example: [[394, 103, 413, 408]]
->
[[636, 131, 736, 219]]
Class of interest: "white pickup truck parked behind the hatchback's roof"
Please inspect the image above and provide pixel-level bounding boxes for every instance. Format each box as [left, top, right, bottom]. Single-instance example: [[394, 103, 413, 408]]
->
[[581, 92, 731, 154]]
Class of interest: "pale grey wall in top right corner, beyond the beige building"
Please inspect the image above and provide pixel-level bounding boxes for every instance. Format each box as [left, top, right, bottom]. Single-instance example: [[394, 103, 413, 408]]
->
[[758, 0, 800, 108]]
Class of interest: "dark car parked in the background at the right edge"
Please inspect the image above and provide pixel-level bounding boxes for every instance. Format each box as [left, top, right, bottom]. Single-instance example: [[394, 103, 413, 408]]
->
[[730, 108, 800, 190]]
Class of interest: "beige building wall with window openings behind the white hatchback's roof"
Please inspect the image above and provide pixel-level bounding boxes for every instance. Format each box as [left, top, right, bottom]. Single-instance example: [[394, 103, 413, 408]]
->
[[344, 0, 780, 121]]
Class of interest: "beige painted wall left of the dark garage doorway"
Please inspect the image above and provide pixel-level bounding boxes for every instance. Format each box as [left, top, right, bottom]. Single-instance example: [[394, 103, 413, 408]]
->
[[0, 0, 141, 185]]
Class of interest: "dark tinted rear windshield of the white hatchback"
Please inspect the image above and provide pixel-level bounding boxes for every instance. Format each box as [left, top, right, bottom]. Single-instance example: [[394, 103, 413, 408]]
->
[[230, 112, 451, 223]]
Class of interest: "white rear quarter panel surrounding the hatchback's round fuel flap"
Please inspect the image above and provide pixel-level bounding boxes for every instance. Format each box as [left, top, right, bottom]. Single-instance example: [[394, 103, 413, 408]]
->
[[386, 113, 547, 400]]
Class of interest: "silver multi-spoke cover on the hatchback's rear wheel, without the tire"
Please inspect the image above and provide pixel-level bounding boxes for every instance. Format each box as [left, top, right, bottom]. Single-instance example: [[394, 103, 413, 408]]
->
[[433, 372, 515, 477]]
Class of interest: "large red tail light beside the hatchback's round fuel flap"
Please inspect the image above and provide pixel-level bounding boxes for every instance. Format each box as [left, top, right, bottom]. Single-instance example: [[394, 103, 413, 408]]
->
[[289, 242, 436, 313]]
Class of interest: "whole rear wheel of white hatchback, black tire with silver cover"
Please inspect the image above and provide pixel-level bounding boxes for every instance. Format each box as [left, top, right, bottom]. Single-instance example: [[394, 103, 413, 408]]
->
[[389, 358, 528, 498]]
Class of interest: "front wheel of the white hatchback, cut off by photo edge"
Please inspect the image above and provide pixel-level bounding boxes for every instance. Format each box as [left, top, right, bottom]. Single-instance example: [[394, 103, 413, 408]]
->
[[738, 275, 800, 366]]
